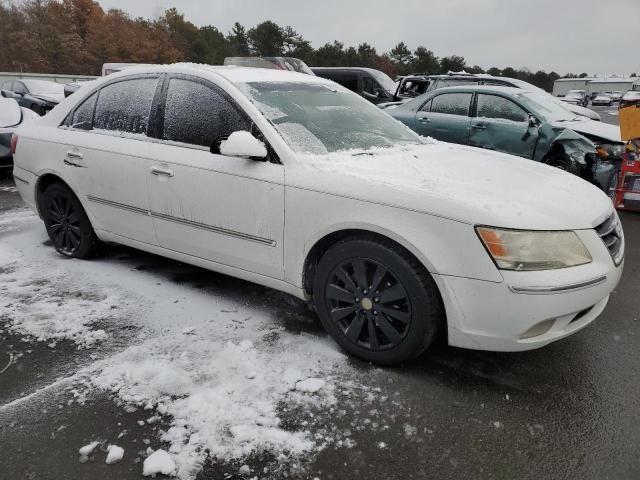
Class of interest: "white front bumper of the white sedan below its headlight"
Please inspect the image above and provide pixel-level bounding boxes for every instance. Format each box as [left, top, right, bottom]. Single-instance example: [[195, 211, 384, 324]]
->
[[434, 230, 623, 352]]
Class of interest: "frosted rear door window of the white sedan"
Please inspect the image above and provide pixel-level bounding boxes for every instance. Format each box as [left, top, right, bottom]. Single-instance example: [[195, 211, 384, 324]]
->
[[93, 78, 158, 134]]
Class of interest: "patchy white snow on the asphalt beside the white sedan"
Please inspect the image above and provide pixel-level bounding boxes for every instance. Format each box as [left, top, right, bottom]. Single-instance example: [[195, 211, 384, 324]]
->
[[0, 210, 368, 479]]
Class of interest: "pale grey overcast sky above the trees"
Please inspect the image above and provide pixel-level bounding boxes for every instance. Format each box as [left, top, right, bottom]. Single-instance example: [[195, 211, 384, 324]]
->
[[99, 0, 640, 74]]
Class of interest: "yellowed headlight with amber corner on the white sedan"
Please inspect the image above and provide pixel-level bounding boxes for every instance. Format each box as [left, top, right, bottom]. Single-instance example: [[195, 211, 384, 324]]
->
[[476, 227, 592, 271]]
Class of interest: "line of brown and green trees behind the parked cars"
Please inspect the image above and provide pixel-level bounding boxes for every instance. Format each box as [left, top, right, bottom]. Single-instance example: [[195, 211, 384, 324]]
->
[[0, 0, 587, 91]]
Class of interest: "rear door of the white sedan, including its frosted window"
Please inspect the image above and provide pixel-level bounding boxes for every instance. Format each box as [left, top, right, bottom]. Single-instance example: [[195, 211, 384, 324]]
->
[[60, 76, 159, 245]]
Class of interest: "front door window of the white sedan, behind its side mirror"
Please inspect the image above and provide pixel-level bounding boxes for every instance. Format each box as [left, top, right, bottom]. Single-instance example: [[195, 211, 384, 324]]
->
[[163, 78, 251, 147]]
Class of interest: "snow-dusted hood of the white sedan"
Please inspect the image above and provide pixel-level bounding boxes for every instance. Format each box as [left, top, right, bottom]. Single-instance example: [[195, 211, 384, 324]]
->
[[286, 141, 612, 230]]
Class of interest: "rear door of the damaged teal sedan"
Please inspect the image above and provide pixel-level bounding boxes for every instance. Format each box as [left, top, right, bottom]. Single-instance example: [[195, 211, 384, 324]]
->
[[415, 92, 473, 145]]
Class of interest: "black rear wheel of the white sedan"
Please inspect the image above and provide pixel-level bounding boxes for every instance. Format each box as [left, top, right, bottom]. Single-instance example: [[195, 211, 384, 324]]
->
[[39, 183, 102, 258]]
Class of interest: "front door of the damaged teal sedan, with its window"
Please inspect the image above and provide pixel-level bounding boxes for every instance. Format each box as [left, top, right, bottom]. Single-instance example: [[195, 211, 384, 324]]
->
[[469, 93, 538, 158]]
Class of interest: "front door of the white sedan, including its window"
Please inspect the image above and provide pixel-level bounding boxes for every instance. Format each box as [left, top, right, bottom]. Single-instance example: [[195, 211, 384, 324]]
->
[[147, 76, 284, 278]]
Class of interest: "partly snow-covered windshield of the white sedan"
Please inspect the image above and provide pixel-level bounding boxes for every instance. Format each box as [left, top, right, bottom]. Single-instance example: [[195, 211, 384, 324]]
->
[[243, 82, 420, 154]]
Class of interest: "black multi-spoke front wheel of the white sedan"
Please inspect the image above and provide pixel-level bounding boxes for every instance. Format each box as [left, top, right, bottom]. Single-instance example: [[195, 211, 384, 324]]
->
[[313, 237, 445, 365]]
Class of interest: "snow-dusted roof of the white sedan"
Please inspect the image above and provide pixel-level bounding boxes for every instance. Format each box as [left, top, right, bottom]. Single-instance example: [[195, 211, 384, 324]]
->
[[104, 63, 333, 84]]
